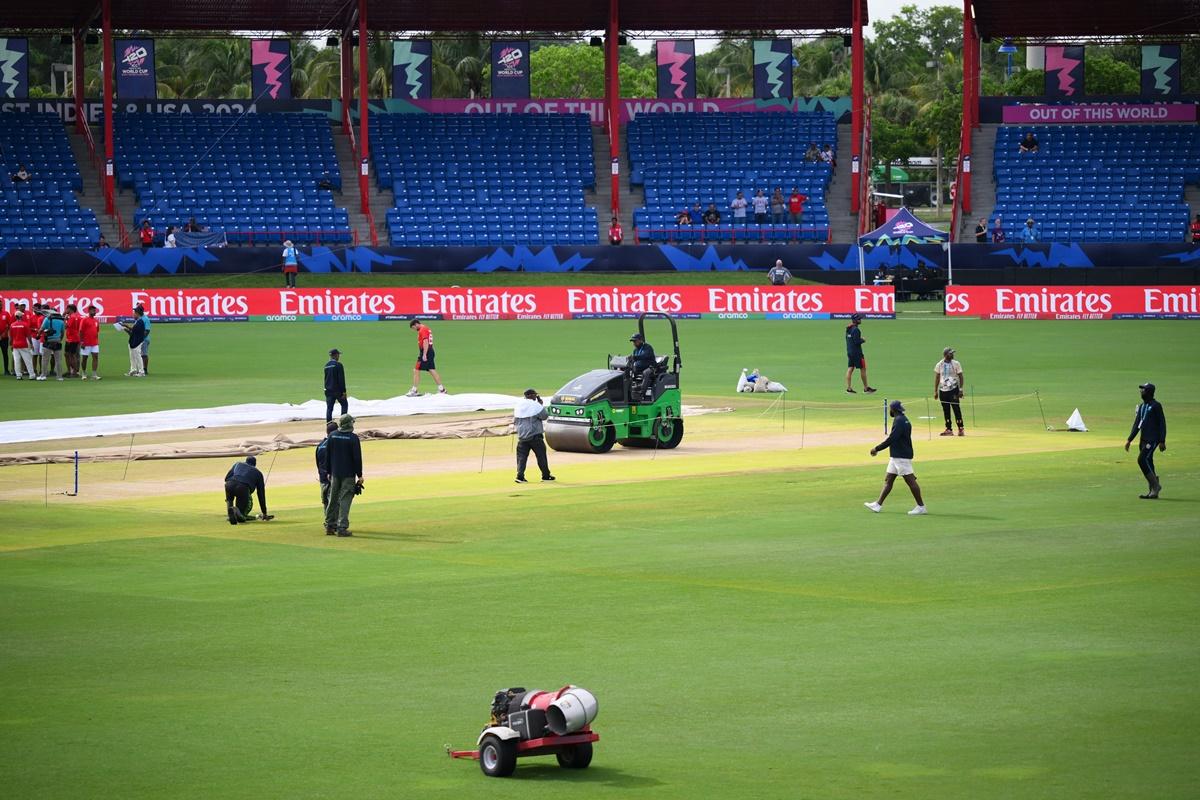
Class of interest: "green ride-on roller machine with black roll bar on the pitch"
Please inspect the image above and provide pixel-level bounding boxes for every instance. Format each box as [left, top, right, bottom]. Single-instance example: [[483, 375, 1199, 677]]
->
[[544, 313, 683, 453]]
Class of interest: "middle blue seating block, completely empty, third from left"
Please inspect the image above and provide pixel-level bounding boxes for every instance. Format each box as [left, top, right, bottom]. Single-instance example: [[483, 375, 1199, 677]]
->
[[371, 114, 599, 246]]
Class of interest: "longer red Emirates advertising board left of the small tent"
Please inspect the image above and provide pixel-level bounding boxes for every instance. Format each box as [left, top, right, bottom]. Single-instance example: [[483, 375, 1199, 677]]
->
[[2, 285, 895, 323]]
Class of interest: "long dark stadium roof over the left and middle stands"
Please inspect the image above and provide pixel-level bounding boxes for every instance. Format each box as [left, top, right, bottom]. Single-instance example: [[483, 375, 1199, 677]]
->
[[0, 0, 868, 31]]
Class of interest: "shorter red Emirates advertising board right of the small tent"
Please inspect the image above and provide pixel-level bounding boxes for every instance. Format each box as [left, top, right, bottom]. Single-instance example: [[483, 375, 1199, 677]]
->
[[946, 285, 1200, 319]]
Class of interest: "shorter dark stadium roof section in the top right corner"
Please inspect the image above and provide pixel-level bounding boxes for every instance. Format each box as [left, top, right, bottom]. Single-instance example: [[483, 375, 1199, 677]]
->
[[974, 0, 1200, 40]]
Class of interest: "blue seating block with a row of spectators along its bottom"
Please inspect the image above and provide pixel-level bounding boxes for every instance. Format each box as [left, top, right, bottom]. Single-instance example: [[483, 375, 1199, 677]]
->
[[626, 112, 838, 241]]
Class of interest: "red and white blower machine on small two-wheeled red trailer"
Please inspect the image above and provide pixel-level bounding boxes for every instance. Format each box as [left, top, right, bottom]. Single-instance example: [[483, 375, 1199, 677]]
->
[[446, 685, 600, 777]]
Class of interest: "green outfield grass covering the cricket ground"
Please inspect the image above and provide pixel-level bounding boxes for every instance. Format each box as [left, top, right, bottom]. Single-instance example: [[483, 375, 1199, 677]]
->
[[0, 318, 1200, 800]]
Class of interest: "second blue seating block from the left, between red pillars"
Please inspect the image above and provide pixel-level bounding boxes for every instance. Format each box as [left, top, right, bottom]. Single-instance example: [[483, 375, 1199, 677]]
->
[[114, 113, 352, 245]]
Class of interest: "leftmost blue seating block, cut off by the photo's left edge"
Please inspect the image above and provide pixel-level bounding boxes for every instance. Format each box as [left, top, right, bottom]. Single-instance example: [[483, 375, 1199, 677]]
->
[[0, 114, 100, 247]]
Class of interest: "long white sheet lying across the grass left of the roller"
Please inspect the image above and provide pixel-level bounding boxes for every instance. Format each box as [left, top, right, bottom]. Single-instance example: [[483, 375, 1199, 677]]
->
[[0, 393, 521, 444]]
